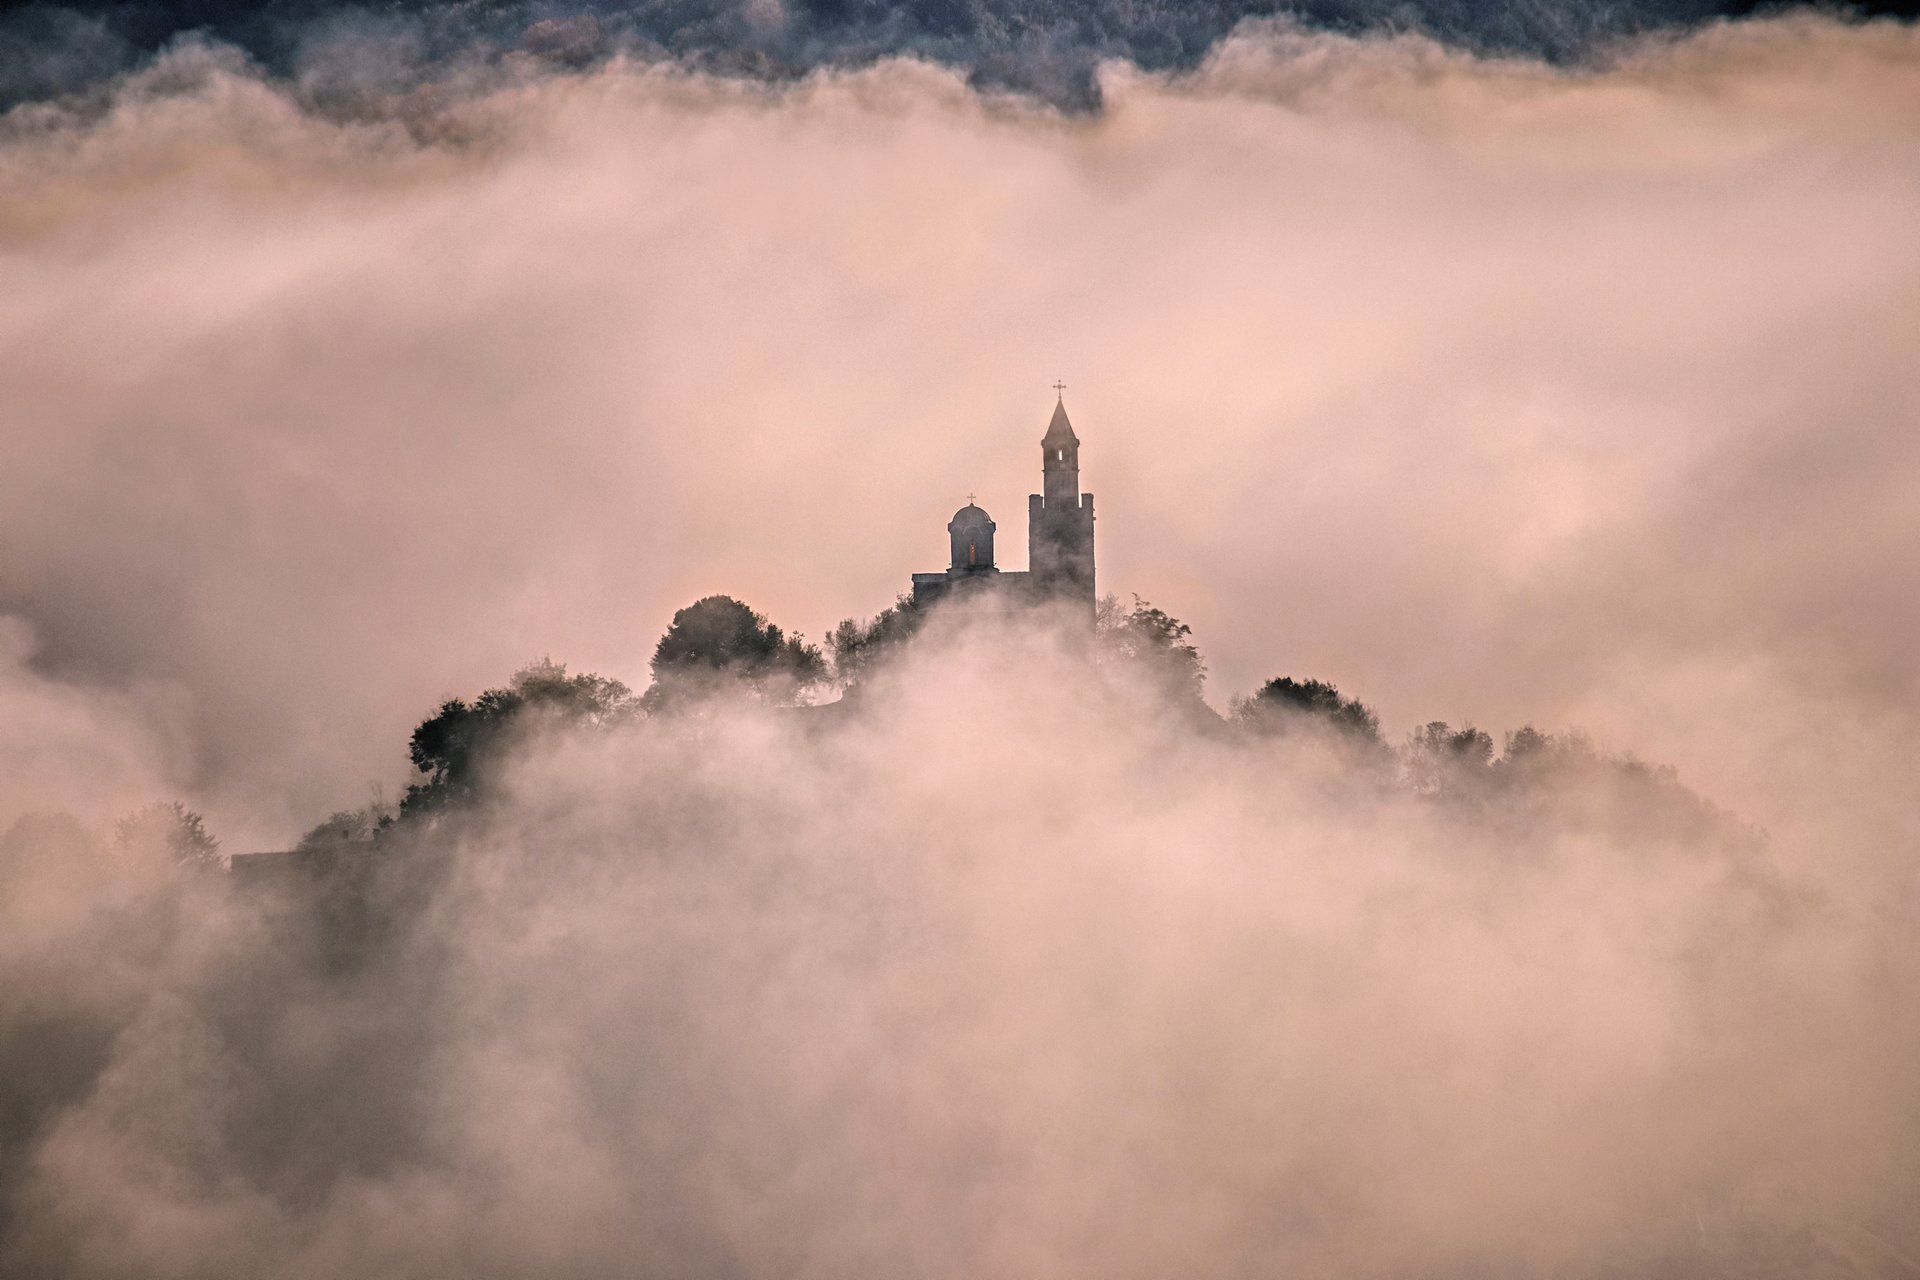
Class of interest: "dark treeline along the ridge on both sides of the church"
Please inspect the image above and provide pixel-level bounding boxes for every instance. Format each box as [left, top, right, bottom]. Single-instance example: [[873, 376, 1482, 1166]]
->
[[0, 595, 1759, 867]]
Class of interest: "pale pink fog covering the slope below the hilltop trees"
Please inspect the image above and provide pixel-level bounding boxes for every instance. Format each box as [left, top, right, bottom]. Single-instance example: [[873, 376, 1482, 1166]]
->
[[0, 614, 1920, 1276]]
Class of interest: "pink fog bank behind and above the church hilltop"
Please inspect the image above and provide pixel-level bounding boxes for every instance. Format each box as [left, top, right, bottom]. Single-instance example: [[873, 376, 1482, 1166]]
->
[[0, 19, 1920, 850]]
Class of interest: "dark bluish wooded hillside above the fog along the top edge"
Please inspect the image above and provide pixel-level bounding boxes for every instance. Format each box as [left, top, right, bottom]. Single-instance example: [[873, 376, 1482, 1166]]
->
[[0, 0, 1916, 106]]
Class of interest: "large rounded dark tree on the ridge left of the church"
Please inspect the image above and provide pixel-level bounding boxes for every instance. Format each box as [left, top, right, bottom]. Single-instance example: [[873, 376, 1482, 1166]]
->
[[641, 595, 828, 712]]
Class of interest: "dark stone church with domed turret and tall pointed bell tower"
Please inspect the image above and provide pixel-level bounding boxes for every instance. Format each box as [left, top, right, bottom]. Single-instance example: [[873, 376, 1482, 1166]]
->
[[914, 395, 1094, 618]]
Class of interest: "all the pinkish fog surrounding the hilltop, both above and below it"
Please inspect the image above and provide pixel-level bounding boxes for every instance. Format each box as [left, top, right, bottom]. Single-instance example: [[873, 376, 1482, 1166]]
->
[[0, 17, 1920, 1276]]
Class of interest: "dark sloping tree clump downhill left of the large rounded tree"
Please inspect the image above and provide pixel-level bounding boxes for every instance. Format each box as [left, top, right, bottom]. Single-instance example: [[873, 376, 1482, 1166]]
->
[[399, 658, 639, 816]]
